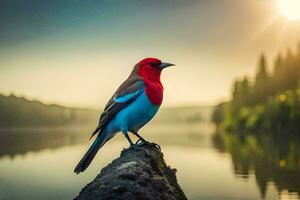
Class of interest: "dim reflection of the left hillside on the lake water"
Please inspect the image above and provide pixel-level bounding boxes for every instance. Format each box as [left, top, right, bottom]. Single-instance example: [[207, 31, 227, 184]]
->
[[0, 127, 89, 158]]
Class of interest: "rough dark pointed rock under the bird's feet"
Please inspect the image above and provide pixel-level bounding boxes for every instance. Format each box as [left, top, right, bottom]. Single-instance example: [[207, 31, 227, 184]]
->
[[75, 144, 187, 200]]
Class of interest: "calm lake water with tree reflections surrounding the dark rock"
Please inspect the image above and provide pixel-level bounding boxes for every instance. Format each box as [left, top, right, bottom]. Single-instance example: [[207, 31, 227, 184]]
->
[[0, 123, 300, 200]]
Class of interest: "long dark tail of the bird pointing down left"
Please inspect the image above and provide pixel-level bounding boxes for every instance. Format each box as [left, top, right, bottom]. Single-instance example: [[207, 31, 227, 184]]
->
[[74, 132, 107, 174]]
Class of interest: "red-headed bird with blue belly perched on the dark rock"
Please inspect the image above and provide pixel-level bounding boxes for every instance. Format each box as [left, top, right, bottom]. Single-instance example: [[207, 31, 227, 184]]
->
[[74, 58, 174, 174]]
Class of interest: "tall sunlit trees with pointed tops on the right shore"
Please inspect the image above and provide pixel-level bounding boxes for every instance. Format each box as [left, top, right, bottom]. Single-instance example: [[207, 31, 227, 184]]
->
[[212, 44, 300, 134]]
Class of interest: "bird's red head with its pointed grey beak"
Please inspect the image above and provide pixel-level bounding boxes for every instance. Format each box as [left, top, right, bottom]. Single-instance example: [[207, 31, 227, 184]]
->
[[136, 58, 174, 81]]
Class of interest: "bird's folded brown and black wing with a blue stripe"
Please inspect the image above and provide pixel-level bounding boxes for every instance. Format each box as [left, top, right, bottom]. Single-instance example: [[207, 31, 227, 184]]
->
[[91, 76, 146, 138]]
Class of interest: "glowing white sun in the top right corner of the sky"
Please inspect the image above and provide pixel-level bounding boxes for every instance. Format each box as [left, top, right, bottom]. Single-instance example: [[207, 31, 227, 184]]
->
[[278, 0, 300, 20]]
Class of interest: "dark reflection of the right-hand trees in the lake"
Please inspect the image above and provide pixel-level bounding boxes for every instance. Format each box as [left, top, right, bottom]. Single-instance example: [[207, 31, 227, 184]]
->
[[213, 133, 300, 199]]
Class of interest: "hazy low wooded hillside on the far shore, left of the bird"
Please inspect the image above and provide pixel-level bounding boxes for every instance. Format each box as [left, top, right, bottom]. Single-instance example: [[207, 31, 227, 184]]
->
[[0, 94, 99, 128]]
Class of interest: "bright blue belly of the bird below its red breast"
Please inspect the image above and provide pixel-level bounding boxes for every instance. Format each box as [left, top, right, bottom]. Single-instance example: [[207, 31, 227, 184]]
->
[[103, 91, 159, 132]]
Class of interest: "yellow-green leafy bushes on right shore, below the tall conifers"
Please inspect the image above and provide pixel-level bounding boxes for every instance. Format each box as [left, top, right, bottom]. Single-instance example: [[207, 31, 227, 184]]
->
[[222, 90, 300, 134]]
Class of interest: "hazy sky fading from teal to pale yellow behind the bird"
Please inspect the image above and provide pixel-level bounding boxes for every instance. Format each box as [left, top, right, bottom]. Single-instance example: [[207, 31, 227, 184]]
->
[[0, 0, 300, 108]]
